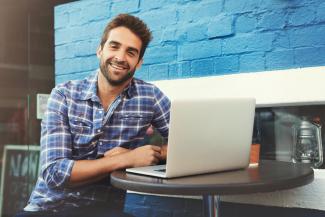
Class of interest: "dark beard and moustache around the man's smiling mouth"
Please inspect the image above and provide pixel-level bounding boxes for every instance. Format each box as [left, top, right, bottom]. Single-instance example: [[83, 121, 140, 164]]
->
[[99, 58, 136, 86]]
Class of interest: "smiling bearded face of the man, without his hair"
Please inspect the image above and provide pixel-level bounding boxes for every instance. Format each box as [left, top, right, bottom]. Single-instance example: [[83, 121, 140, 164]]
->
[[97, 27, 142, 86]]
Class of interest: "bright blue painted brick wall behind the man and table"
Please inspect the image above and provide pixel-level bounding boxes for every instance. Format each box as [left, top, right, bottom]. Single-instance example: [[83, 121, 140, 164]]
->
[[55, 0, 325, 217]]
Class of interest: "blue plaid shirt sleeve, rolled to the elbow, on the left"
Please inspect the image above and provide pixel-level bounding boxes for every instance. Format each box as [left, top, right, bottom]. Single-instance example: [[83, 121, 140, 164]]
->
[[41, 88, 74, 188]]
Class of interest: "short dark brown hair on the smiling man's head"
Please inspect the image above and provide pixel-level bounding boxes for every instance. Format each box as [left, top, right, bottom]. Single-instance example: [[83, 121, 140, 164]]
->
[[100, 14, 152, 60]]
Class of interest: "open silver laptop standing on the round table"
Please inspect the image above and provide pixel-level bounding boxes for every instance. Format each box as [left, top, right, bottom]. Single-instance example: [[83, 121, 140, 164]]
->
[[126, 98, 255, 178]]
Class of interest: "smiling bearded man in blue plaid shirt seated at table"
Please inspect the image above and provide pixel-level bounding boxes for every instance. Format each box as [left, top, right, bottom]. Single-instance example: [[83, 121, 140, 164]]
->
[[18, 14, 170, 217]]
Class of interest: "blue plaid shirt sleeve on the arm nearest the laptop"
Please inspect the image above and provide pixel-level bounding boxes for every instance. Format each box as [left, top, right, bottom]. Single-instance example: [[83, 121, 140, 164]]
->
[[152, 87, 170, 141]]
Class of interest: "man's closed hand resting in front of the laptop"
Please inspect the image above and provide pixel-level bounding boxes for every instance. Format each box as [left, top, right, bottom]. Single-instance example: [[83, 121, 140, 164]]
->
[[126, 145, 162, 167]]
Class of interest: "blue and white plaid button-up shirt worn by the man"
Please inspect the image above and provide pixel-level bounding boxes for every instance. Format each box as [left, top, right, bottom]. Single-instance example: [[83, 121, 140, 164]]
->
[[25, 71, 170, 211]]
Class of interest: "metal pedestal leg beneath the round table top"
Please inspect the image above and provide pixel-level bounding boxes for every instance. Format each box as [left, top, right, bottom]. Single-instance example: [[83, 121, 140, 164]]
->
[[203, 195, 221, 217]]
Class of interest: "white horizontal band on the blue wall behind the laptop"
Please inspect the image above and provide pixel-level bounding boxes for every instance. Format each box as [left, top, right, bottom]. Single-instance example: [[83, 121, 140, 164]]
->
[[153, 66, 325, 107]]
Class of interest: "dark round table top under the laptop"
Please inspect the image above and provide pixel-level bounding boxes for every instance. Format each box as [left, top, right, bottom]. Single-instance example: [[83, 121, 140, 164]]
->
[[111, 160, 314, 195]]
